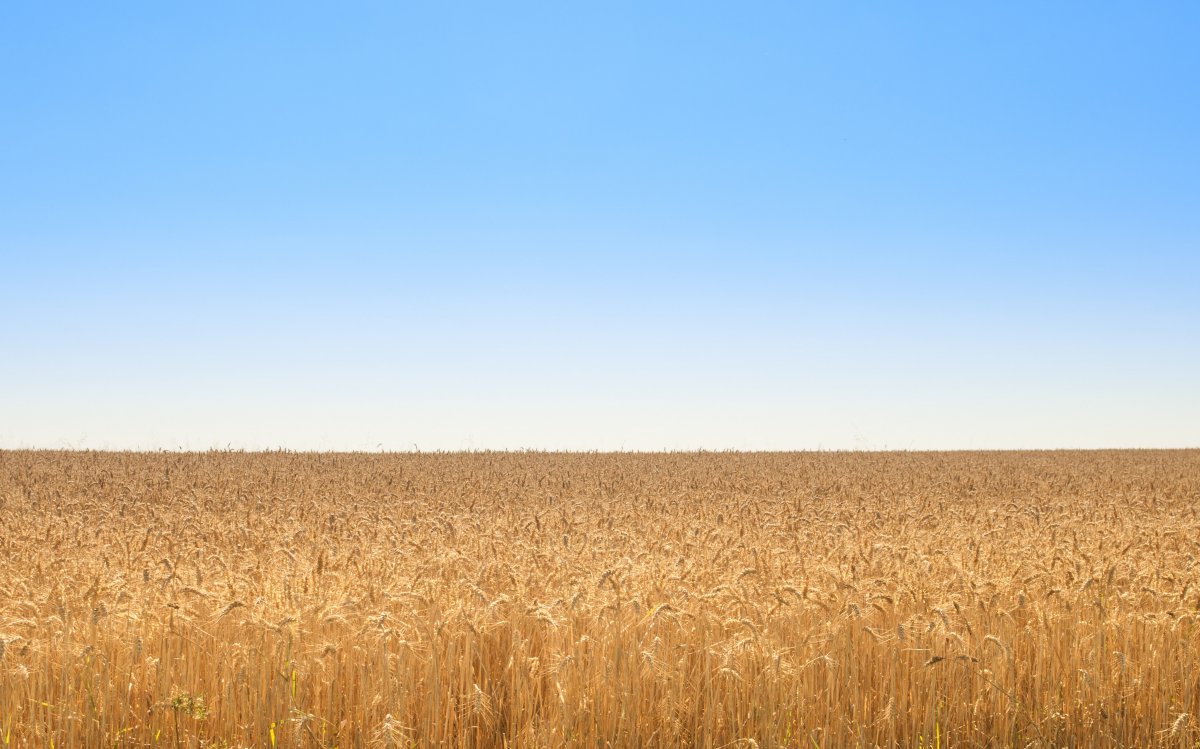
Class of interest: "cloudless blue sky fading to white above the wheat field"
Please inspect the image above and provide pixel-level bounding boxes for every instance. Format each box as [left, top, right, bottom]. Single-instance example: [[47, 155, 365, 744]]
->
[[0, 1, 1200, 450]]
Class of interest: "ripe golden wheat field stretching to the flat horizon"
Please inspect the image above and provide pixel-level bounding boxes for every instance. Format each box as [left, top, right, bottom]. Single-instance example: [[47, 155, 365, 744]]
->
[[0, 450, 1200, 749]]
